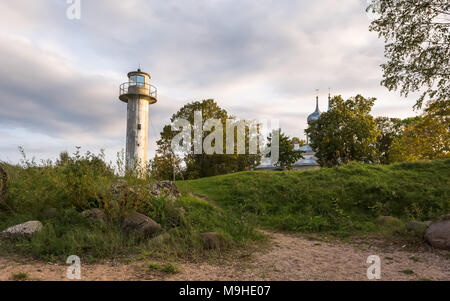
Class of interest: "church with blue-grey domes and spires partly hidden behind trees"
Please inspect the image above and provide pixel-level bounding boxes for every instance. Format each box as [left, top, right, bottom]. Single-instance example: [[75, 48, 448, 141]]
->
[[255, 94, 331, 171]]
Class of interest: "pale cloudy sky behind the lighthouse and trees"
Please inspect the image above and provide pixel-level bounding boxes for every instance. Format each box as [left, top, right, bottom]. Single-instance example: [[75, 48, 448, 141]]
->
[[0, 0, 417, 162]]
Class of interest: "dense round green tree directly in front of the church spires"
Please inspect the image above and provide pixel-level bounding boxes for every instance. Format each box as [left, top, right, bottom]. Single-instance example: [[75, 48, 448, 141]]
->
[[306, 95, 379, 167]]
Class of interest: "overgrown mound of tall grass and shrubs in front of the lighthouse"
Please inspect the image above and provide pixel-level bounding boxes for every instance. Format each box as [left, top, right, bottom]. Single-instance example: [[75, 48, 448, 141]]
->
[[0, 150, 262, 261]]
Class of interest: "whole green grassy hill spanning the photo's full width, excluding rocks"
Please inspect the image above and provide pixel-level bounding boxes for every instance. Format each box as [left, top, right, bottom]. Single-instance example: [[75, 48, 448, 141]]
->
[[0, 157, 450, 260]]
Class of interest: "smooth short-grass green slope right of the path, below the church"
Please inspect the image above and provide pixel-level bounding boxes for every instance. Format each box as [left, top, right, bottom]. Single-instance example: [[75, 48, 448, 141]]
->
[[177, 160, 450, 236]]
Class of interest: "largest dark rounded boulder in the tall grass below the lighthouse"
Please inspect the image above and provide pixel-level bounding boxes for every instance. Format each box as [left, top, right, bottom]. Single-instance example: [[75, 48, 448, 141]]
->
[[122, 211, 161, 238]]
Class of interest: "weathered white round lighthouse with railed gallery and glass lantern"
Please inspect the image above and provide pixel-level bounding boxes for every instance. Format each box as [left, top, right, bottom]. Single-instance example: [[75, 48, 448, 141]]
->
[[119, 69, 157, 175]]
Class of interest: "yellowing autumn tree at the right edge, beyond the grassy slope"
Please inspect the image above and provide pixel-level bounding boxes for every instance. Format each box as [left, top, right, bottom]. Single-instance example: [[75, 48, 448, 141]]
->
[[389, 102, 450, 162]]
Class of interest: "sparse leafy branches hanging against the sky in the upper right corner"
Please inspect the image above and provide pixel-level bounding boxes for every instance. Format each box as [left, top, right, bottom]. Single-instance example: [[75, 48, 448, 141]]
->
[[367, 0, 450, 109]]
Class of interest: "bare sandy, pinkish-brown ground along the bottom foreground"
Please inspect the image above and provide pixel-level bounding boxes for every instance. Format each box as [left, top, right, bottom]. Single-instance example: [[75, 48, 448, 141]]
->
[[0, 233, 450, 281]]
